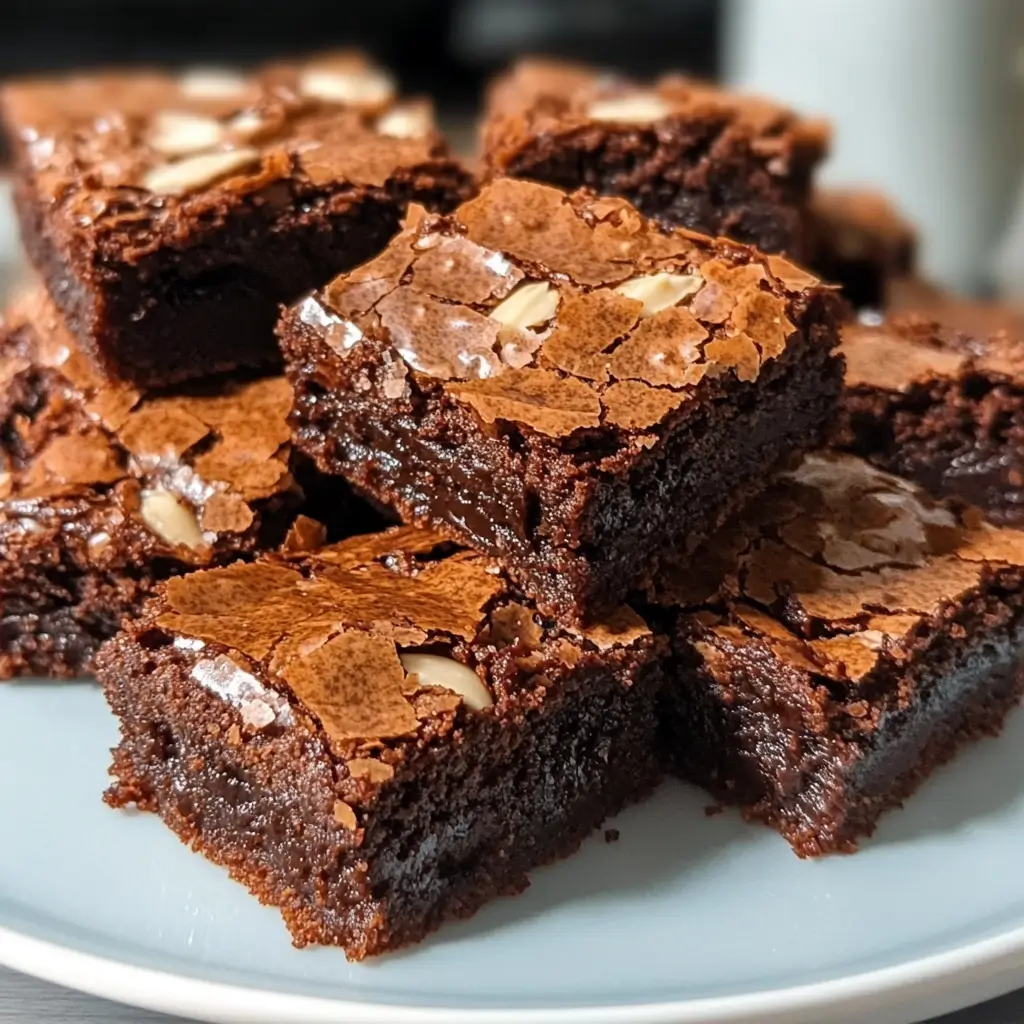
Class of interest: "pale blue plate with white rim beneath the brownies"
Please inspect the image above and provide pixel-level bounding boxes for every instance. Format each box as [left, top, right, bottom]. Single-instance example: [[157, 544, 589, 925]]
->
[[0, 684, 1024, 1024]]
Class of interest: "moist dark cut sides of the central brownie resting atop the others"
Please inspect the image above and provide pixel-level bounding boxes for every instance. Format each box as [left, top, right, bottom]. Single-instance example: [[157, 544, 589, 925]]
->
[[279, 310, 843, 625]]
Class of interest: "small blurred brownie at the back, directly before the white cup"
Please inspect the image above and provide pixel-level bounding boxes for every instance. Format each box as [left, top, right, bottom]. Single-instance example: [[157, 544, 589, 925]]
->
[[810, 188, 918, 309]]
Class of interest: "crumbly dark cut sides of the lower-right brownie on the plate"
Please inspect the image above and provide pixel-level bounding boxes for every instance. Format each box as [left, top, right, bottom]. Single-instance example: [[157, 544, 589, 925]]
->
[[659, 570, 1024, 857]]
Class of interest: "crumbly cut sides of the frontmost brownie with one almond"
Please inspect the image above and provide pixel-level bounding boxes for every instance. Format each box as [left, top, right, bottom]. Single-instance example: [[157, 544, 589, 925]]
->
[[97, 622, 659, 959]]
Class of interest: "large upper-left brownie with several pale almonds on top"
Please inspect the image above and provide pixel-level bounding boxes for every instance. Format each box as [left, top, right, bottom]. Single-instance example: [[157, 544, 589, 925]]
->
[[0, 53, 468, 386]]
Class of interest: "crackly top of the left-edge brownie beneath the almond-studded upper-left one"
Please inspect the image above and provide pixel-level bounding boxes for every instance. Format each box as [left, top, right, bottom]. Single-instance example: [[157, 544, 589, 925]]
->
[[0, 288, 295, 562]]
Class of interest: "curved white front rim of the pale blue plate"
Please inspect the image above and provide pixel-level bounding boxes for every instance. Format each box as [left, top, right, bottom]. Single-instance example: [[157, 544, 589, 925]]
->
[[0, 925, 1024, 1024]]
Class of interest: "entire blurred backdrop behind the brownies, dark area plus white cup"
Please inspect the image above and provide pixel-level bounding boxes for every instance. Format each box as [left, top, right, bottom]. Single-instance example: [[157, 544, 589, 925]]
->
[[0, 0, 1024, 301]]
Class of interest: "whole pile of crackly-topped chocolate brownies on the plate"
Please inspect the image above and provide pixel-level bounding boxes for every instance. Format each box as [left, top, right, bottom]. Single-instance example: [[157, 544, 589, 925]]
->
[[8, 49, 1024, 958]]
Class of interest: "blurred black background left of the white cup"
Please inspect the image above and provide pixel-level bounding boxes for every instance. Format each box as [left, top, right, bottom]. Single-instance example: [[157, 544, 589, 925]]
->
[[0, 0, 720, 113]]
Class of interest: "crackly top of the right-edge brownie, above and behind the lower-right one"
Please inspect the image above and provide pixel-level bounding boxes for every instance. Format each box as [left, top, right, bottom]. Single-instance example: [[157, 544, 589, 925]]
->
[[841, 313, 1024, 391]]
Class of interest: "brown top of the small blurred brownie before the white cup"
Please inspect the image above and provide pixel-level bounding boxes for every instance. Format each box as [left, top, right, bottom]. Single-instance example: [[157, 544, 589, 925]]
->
[[811, 188, 918, 269]]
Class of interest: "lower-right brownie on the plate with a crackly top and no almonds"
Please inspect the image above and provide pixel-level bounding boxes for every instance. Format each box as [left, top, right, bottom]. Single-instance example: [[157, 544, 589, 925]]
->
[[658, 453, 1024, 856]]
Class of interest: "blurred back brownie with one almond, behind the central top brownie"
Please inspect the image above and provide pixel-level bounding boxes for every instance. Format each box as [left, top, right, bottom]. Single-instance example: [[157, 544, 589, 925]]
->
[[481, 58, 828, 258]]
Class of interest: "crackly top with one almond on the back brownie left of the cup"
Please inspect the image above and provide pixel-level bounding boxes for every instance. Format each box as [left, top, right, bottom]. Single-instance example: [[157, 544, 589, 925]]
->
[[483, 58, 828, 166]]
